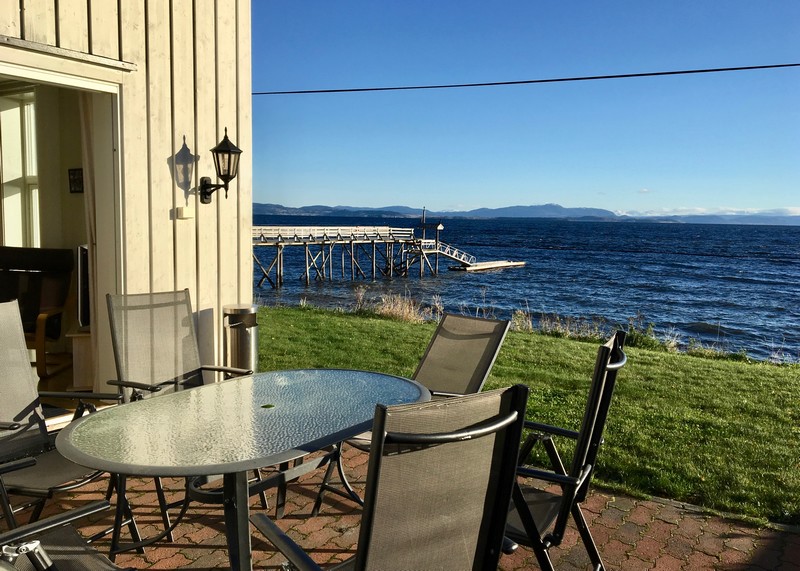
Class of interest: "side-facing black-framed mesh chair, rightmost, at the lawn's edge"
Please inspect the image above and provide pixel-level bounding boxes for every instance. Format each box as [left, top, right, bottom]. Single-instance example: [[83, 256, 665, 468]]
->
[[504, 331, 627, 571]]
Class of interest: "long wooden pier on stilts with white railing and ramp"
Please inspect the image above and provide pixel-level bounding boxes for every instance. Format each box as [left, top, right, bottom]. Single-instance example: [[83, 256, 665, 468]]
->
[[253, 226, 524, 288]]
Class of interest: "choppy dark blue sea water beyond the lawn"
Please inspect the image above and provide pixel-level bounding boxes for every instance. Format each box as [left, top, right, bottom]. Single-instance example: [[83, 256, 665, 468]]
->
[[253, 216, 800, 362]]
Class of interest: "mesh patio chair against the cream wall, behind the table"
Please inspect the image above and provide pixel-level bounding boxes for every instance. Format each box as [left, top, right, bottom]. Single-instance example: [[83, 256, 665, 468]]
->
[[106, 289, 260, 541]]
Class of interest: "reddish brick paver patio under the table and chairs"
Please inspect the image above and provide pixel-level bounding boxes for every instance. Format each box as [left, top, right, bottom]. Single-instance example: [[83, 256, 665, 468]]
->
[[25, 449, 800, 571]]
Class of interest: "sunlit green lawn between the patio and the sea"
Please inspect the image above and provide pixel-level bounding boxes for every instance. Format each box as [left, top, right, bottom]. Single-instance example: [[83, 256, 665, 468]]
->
[[259, 307, 800, 524]]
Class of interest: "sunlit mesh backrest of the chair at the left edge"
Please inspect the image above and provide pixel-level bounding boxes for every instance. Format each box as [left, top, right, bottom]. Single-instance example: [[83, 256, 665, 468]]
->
[[0, 301, 48, 461]]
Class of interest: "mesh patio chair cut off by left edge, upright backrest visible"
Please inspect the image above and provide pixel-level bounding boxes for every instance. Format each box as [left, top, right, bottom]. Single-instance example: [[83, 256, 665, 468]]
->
[[0, 301, 120, 528]]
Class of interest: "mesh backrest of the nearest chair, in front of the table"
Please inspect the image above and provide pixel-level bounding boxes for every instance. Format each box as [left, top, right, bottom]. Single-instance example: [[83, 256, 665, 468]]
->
[[355, 385, 528, 571]]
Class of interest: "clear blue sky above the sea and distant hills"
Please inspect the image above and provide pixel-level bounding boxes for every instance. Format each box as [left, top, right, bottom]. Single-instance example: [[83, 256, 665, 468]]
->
[[246, 0, 800, 214]]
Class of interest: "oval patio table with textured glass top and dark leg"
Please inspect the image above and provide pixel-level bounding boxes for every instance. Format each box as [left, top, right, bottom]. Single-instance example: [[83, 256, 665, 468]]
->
[[56, 369, 430, 571]]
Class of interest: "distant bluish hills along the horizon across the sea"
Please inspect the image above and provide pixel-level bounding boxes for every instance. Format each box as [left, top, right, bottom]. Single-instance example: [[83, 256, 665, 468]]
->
[[253, 202, 800, 226]]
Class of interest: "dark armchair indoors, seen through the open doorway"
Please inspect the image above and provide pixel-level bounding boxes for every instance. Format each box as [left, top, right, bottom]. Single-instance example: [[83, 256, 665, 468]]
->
[[0, 246, 75, 339]]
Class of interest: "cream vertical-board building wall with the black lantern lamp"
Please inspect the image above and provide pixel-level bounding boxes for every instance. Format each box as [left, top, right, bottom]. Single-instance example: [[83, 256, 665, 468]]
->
[[0, 0, 252, 384]]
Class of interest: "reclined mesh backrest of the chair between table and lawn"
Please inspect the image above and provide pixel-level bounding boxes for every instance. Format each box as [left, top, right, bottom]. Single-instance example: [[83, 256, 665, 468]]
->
[[413, 313, 511, 395]]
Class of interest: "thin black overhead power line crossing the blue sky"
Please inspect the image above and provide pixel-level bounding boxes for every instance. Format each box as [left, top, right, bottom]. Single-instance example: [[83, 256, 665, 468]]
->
[[253, 63, 800, 95]]
